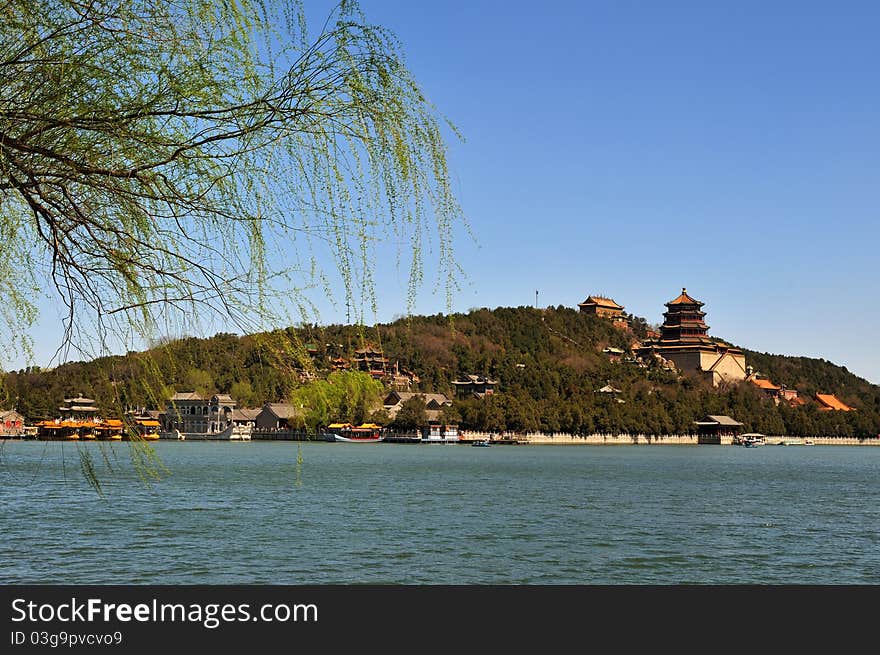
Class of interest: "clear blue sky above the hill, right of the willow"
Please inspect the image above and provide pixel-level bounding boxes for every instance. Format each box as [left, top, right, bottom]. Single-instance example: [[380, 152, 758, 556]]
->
[[13, 0, 880, 383]]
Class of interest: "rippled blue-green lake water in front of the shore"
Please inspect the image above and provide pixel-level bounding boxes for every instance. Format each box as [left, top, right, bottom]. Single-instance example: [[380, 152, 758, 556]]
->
[[0, 441, 880, 585]]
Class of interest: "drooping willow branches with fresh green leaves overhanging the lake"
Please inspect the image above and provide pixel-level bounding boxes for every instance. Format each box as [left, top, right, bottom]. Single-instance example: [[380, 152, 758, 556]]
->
[[0, 0, 460, 366]]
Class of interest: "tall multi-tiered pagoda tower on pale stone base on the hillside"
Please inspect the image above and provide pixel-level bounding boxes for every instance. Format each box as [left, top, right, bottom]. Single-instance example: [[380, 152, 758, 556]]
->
[[639, 288, 746, 386]]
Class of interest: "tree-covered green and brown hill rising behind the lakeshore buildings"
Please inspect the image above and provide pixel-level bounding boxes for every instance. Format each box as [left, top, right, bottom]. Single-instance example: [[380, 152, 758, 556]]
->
[[3, 307, 880, 436]]
